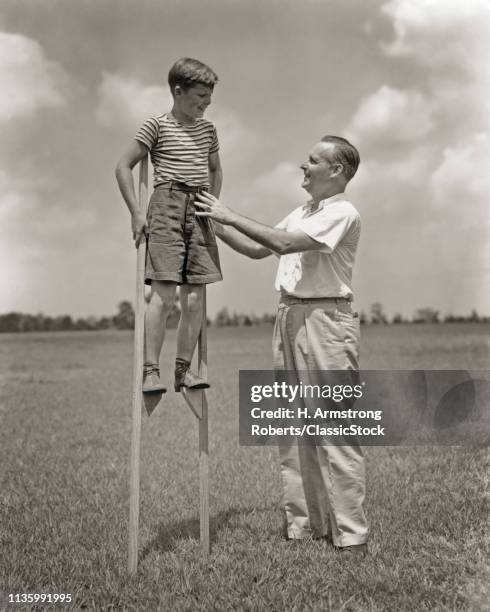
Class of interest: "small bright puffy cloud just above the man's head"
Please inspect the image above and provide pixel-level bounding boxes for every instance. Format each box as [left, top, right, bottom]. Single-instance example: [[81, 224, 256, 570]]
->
[[347, 85, 435, 145]]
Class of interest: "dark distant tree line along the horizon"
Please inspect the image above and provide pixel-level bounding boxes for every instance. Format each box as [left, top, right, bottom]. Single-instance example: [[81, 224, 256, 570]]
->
[[0, 300, 490, 333]]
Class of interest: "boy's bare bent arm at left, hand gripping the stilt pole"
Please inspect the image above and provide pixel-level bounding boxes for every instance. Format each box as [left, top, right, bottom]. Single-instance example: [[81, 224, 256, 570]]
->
[[116, 140, 148, 247]]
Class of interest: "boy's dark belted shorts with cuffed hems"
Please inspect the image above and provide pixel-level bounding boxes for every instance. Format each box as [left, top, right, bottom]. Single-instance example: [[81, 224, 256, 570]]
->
[[145, 181, 223, 285]]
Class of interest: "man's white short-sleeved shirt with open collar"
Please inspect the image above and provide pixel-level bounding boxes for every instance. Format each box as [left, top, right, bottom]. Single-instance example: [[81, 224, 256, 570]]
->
[[276, 193, 361, 299]]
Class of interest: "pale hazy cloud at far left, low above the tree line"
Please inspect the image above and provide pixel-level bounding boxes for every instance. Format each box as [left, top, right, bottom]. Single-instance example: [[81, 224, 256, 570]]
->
[[0, 172, 110, 313]]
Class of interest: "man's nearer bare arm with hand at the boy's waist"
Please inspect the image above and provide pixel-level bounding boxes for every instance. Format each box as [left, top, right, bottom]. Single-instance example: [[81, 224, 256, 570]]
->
[[196, 193, 324, 257]]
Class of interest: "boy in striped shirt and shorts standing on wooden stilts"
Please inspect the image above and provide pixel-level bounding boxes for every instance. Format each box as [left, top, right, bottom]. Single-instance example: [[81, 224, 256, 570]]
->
[[116, 58, 222, 393]]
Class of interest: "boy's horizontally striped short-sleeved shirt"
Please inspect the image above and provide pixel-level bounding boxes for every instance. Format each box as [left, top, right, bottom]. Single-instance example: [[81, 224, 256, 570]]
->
[[135, 114, 219, 187]]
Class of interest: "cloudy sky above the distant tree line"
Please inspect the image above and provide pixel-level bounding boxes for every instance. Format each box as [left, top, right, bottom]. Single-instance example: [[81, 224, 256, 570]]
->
[[0, 0, 490, 316]]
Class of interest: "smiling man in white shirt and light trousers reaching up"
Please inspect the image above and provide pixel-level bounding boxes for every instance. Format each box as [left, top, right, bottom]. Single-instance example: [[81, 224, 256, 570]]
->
[[196, 136, 368, 556]]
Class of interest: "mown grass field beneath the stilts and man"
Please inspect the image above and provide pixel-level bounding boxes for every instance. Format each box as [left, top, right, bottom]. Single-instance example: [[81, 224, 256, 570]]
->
[[0, 324, 490, 612]]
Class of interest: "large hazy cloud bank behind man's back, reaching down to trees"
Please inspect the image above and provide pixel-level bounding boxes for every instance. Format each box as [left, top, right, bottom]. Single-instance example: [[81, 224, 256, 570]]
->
[[348, 133, 490, 314]]
